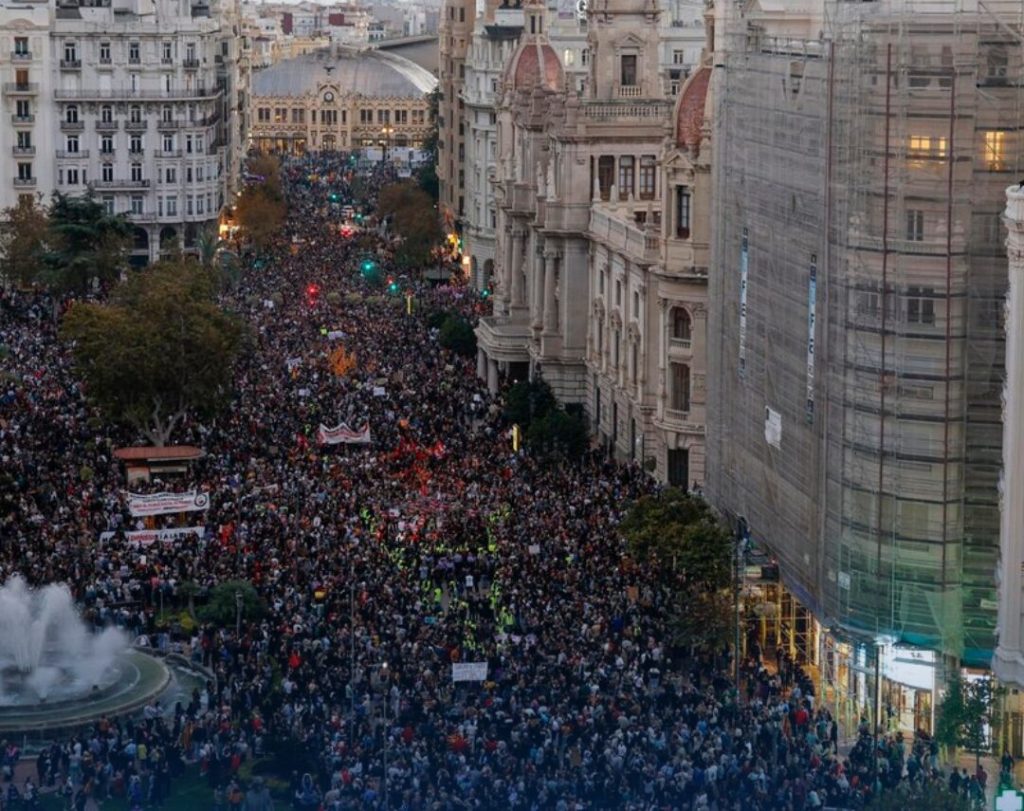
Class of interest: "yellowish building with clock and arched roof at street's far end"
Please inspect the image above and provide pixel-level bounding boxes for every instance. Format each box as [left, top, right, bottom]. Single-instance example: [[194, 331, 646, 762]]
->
[[250, 46, 437, 155]]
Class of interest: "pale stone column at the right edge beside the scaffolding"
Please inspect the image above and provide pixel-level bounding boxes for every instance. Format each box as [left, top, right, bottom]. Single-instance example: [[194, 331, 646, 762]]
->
[[992, 185, 1024, 686]]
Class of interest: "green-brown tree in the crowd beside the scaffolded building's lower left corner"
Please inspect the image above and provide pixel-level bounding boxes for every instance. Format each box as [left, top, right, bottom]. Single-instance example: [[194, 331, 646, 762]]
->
[[618, 487, 733, 650]]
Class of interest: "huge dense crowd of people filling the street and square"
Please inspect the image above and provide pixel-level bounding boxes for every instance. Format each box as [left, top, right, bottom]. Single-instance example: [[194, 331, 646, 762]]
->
[[0, 156, 983, 811]]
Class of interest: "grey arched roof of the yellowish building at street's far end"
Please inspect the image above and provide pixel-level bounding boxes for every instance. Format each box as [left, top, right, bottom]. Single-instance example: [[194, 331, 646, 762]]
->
[[252, 46, 437, 98]]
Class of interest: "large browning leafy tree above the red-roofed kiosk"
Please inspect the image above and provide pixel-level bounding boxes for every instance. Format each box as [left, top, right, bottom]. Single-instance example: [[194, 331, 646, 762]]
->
[[62, 260, 243, 446]]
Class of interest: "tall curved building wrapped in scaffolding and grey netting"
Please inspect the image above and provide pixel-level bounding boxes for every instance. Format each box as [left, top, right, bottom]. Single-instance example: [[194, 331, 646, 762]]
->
[[707, 0, 1024, 728]]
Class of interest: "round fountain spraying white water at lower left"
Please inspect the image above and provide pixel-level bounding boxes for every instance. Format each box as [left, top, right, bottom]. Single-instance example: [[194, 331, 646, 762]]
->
[[0, 577, 171, 732]]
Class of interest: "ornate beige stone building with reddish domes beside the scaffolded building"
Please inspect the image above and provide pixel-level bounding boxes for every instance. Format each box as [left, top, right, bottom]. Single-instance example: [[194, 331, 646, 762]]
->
[[477, 0, 711, 485]]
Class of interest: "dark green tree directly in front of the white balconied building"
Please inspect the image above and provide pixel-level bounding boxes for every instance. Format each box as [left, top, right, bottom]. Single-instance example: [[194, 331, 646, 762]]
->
[[41, 193, 132, 294]]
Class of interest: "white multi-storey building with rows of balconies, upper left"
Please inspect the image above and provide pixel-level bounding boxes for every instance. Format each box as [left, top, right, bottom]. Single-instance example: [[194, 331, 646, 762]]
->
[[0, 0, 247, 262]]
